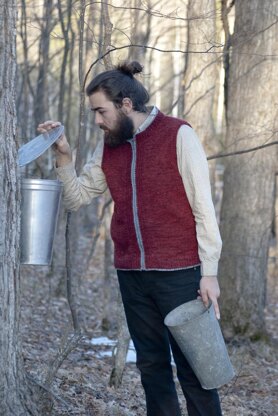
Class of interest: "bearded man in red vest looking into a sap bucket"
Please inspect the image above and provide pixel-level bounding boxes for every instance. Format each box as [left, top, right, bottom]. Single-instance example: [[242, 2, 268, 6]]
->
[[39, 62, 221, 416]]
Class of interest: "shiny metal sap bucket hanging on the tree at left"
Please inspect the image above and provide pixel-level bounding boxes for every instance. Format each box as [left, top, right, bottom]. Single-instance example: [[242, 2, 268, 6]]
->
[[20, 179, 63, 265]]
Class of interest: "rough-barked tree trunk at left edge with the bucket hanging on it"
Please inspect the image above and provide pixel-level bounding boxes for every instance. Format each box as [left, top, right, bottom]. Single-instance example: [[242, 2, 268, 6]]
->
[[0, 0, 38, 416]]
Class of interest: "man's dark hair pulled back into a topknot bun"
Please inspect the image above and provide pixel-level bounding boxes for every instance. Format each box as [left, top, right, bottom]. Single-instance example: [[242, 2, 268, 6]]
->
[[86, 61, 150, 113]]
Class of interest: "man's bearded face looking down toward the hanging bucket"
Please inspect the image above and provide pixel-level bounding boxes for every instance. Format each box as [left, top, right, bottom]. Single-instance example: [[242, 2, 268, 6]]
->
[[89, 91, 134, 147]]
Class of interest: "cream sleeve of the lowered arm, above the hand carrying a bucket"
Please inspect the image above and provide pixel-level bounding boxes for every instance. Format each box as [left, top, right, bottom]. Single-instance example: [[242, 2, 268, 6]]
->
[[177, 125, 222, 276]]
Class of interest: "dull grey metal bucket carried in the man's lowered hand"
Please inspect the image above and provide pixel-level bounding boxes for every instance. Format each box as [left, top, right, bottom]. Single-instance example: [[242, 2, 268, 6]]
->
[[164, 299, 235, 390]]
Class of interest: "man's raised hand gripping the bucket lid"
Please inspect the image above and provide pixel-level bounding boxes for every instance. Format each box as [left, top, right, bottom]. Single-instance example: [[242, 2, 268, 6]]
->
[[38, 120, 72, 167]]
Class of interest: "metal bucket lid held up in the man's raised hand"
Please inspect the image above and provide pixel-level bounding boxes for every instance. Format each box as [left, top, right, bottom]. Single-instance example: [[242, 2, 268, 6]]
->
[[18, 125, 64, 167]]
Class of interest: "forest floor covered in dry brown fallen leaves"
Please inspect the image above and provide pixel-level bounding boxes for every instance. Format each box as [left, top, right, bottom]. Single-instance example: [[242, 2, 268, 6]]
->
[[21, 231, 278, 416]]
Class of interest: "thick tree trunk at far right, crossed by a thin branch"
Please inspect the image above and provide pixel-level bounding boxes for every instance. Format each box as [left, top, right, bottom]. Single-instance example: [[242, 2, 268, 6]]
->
[[219, 0, 278, 337]]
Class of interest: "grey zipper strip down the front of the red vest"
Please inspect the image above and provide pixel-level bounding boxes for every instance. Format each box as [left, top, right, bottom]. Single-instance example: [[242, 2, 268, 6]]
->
[[129, 138, 146, 270]]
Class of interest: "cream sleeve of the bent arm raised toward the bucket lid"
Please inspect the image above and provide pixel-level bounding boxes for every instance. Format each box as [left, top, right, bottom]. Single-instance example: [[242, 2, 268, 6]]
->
[[56, 141, 107, 211]]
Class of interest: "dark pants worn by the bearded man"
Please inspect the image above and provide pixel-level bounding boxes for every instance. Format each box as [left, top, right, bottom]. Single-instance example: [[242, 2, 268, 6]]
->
[[117, 267, 222, 416]]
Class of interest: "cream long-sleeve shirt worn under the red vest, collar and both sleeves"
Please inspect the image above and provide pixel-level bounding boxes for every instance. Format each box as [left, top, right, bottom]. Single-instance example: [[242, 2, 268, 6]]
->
[[56, 107, 222, 276]]
